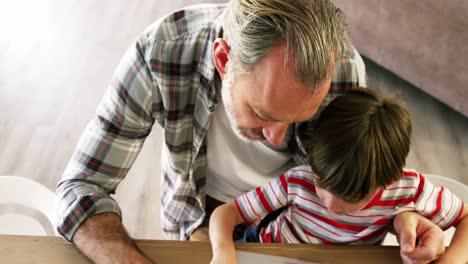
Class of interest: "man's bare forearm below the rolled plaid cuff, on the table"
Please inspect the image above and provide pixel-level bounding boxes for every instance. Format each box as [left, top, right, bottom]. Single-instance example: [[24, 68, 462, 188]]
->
[[73, 213, 153, 264]]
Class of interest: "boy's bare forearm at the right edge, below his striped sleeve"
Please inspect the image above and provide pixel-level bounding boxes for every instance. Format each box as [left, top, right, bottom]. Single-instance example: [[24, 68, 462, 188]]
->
[[437, 203, 468, 264]]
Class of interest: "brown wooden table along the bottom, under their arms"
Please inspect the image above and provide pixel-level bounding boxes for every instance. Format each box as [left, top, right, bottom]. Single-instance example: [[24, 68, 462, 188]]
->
[[0, 235, 401, 264]]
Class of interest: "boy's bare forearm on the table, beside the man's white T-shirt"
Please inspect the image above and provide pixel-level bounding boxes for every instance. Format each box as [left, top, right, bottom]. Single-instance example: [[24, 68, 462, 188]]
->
[[209, 201, 244, 264]]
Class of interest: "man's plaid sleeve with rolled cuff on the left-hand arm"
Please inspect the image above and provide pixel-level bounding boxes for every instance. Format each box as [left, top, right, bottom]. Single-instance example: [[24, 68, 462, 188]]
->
[[56, 33, 160, 241]]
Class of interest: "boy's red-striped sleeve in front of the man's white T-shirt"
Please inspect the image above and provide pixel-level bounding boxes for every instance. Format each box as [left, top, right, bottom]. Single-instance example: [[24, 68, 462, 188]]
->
[[234, 174, 288, 224]]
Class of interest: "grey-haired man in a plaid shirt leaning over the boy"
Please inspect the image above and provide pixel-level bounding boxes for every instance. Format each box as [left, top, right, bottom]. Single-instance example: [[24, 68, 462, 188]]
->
[[57, 0, 440, 263]]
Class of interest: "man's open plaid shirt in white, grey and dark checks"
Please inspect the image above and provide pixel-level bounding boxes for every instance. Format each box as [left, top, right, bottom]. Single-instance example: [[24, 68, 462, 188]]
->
[[57, 4, 366, 240]]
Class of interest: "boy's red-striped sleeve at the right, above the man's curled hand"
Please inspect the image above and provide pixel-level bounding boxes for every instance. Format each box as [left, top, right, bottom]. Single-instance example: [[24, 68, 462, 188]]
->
[[415, 174, 464, 230]]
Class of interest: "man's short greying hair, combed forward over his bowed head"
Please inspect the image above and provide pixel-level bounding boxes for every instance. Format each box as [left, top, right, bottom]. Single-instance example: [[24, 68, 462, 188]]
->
[[223, 0, 348, 88]]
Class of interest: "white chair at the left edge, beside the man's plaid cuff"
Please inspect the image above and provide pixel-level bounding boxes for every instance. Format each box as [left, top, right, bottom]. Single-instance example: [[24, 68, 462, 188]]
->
[[0, 176, 57, 236]]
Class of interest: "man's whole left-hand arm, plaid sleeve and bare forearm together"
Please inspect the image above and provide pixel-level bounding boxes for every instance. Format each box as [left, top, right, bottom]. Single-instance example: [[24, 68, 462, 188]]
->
[[56, 32, 162, 263]]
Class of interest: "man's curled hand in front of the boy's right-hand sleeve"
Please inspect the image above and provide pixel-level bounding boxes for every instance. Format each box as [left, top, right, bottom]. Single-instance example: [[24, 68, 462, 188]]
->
[[393, 212, 445, 264]]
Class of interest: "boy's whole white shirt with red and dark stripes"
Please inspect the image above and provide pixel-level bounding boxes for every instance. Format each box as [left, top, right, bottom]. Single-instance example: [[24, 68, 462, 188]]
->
[[235, 166, 464, 244]]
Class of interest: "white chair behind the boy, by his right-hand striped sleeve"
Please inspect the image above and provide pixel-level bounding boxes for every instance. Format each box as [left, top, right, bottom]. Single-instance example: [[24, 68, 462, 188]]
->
[[382, 174, 468, 246]]
